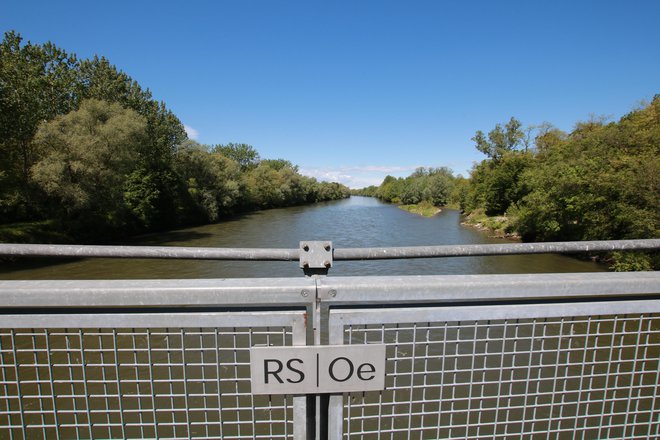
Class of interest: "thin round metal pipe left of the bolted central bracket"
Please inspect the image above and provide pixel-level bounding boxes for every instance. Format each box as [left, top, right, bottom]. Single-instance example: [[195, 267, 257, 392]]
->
[[0, 243, 299, 261]]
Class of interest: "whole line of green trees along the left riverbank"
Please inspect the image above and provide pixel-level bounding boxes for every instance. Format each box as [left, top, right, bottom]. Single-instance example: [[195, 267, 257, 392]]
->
[[0, 32, 349, 241]]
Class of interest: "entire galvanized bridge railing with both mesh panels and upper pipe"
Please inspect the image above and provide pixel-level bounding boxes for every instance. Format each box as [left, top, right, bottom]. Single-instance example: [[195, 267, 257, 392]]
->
[[0, 240, 660, 439]]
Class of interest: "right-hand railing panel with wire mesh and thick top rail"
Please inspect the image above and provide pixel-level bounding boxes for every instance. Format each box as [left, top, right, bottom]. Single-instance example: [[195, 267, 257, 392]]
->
[[319, 273, 660, 439]]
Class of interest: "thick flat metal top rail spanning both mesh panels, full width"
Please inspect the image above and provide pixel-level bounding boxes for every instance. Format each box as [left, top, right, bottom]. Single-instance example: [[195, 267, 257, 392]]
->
[[0, 272, 660, 308]]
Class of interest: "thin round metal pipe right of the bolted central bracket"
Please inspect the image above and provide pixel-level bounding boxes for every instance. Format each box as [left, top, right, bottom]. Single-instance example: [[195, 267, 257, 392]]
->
[[334, 239, 660, 260]]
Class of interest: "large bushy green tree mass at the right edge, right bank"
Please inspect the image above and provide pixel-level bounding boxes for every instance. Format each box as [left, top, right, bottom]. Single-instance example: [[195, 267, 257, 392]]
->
[[518, 98, 660, 244]]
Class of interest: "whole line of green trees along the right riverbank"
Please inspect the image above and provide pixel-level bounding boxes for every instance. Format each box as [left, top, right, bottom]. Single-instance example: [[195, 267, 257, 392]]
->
[[359, 95, 660, 270]]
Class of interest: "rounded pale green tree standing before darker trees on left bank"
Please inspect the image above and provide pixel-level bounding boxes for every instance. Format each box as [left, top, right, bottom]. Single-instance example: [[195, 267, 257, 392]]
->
[[31, 99, 147, 232]]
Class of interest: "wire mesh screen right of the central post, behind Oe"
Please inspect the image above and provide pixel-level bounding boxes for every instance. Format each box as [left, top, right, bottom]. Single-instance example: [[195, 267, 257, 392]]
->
[[342, 311, 660, 439]]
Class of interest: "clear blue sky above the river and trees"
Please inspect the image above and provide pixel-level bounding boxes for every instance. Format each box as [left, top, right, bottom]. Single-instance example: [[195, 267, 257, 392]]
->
[[0, 0, 660, 187]]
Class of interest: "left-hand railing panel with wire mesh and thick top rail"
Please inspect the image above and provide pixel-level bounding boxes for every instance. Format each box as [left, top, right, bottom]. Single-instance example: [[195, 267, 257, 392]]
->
[[0, 279, 314, 439]]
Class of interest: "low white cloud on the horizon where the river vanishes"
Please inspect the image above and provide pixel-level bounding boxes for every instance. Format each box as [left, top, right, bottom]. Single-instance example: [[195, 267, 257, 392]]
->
[[300, 165, 417, 188]]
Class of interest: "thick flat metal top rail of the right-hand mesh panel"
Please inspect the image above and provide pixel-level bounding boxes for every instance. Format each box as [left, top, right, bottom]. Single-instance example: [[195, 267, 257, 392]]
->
[[317, 272, 660, 305]]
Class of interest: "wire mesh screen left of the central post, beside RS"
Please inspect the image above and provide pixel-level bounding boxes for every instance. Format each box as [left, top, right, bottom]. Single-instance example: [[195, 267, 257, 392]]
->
[[0, 327, 293, 439]]
